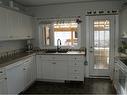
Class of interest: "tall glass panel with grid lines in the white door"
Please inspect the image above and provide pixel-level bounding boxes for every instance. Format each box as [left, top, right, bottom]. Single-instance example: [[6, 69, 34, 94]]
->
[[94, 20, 110, 69]]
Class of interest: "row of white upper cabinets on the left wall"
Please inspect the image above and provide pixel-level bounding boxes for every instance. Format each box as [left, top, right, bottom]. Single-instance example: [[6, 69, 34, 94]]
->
[[0, 7, 33, 41]]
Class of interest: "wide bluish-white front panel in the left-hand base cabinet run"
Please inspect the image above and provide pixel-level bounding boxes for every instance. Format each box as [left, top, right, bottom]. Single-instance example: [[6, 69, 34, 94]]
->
[[6, 65, 24, 94]]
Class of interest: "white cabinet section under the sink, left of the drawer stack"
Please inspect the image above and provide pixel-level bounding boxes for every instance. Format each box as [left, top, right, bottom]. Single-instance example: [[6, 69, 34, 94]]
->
[[36, 55, 67, 80]]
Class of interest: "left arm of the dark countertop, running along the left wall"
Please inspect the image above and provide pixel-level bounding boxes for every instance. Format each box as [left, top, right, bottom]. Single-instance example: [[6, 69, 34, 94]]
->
[[0, 52, 35, 68]]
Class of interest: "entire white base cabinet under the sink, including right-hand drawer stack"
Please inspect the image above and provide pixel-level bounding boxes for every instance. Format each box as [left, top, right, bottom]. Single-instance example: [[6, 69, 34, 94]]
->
[[36, 54, 84, 81]]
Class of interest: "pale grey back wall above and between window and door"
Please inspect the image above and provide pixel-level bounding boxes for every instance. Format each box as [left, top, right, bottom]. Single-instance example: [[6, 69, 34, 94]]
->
[[27, 0, 123, 46]]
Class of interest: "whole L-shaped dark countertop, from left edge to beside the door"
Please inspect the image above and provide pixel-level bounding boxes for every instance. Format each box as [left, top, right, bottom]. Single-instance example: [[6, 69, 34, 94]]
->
[[0, 51, 85, 68]]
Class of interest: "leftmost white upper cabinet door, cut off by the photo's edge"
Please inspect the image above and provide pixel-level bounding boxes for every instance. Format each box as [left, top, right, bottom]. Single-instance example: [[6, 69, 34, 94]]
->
[[0, 7, 9, 40]]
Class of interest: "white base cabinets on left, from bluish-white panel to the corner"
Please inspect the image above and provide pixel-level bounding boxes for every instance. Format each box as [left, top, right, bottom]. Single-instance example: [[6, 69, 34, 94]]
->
[[6, 56, 35, 94]]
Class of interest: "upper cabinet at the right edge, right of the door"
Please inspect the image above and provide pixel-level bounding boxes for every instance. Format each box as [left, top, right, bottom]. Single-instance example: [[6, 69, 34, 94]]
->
[[120, 7, 127, 38]]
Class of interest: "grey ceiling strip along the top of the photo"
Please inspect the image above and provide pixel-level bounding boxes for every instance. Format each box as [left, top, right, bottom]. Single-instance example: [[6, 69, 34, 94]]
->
[[14, 0, 124, 6]]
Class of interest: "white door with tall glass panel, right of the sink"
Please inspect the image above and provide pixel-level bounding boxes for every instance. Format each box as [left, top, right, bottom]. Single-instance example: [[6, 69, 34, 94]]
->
[[88, 15, 114, 77]]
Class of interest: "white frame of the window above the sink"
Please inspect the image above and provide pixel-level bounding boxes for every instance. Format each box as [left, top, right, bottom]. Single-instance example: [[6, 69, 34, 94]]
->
[[38, 22, 81, 49]]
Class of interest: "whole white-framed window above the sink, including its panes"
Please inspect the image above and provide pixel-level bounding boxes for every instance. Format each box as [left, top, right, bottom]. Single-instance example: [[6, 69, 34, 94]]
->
[[39, 16, 81, 48]]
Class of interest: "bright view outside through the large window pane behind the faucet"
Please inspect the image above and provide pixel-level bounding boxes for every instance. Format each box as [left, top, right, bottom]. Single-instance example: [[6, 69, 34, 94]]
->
[[54, 22, 78, 46]]
